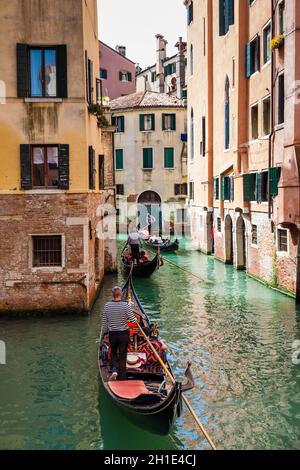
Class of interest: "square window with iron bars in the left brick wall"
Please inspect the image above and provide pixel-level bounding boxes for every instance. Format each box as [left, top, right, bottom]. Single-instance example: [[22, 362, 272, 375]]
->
[[32, 235, 62, 268]]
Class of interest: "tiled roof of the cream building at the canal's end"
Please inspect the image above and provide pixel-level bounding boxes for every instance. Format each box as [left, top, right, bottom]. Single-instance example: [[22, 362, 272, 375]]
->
[[110, 91, 185, 111]]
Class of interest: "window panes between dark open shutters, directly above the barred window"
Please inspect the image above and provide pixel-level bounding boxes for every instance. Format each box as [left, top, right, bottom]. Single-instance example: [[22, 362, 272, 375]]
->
[[32, 146, 59, 188]]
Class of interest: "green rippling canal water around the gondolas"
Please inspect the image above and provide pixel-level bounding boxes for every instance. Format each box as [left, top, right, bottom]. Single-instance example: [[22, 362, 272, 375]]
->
[[0, 241, 300, 450]]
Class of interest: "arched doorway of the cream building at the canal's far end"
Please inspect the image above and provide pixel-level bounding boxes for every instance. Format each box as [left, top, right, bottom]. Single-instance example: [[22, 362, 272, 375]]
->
[[138, 191, 162, 235]]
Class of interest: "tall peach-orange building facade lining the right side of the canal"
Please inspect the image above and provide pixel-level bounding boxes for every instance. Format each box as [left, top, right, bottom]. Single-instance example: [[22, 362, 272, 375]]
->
[[185, 0, 300, 297]]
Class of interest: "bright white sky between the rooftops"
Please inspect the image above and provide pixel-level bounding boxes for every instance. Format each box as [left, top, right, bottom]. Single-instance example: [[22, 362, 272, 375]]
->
[[98, 0, 186, 68]]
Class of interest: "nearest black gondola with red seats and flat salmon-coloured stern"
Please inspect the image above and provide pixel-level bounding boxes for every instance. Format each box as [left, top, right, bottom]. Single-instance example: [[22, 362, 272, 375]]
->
[[99, 274, 194, 435]]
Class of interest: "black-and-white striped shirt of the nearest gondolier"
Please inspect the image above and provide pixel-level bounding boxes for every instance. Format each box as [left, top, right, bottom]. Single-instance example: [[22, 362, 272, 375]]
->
[[102, 300, 136, 334]]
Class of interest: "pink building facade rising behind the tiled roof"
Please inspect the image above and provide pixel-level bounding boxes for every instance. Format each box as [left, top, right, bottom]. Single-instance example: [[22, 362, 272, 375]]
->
[[99, 41, 136, 100]]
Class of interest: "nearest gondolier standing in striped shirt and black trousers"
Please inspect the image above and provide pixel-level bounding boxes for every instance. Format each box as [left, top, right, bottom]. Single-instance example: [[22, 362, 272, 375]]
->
[[102, 287, 136, 380]]
